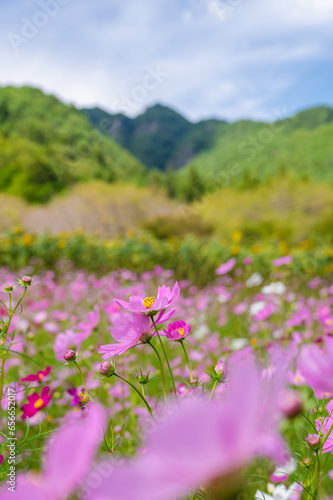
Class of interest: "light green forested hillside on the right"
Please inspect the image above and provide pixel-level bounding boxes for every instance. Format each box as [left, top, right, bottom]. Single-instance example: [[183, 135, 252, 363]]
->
[[177, 107, 333, 192]]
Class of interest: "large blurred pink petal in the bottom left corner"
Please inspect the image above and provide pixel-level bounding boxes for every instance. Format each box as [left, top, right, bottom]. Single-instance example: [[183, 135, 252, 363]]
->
[[0, 406, 104, 500]]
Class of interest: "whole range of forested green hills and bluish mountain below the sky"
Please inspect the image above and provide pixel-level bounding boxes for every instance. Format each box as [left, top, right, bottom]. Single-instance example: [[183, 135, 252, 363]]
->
[[0, 87, 333, 207]]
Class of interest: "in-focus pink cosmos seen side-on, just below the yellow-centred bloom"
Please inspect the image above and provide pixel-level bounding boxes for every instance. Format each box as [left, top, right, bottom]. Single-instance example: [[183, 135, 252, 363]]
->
[[98, 309, 176, 359]]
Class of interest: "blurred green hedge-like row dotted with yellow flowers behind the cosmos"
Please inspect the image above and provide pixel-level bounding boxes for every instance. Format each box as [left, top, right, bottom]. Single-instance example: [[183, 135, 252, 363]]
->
[[0, 232, 333, 287]]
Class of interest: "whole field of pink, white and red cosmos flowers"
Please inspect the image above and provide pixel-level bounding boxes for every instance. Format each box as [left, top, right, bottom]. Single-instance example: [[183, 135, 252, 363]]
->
[[0, 255, 333, 500]]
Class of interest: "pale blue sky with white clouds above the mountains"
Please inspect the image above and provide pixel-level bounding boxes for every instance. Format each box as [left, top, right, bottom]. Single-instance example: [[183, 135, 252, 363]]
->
[[0, 0, 333, 120]]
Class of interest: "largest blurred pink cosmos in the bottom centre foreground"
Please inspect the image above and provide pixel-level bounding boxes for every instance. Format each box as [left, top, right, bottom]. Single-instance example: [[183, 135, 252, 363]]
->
[[94, 361, 286, 500]]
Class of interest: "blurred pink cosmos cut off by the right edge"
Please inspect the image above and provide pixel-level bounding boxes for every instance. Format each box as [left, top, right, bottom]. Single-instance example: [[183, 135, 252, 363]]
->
[[297, 340, 333, 397]]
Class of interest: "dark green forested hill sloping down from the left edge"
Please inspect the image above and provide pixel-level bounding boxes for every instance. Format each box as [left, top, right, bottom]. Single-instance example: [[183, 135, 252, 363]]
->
[[0, 87, 143, 202]]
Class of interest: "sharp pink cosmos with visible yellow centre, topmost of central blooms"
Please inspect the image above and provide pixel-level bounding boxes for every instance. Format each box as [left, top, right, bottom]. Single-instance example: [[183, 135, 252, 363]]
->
[[113, 282, 180, 315]]
